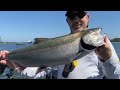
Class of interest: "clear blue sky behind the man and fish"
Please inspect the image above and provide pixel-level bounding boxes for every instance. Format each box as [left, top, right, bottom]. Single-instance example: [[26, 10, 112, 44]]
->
[[0, 11, 120, 42]]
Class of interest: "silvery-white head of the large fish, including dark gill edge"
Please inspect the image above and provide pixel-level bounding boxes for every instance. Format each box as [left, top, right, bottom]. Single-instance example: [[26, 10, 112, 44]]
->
[[81, 28, 104, 49]]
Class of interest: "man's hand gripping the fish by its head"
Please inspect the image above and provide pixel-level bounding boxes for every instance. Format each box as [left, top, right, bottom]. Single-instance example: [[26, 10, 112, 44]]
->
[[96, 36, 112, 62]]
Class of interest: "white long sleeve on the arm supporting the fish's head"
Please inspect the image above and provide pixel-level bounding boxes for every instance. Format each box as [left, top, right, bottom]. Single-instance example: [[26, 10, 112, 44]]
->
[[101, 41, 120, 79]]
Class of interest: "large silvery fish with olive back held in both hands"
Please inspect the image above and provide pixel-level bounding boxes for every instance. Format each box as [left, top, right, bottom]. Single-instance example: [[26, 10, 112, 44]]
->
[[6, 28, 104, 67]]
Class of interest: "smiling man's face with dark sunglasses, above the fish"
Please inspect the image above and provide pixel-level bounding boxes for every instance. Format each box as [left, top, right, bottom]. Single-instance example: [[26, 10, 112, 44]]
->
[[67, 11, 89, 33]]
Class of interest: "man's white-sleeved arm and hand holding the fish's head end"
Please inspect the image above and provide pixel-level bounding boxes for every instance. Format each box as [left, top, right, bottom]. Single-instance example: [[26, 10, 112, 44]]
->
[[97, 37, 120, 79]]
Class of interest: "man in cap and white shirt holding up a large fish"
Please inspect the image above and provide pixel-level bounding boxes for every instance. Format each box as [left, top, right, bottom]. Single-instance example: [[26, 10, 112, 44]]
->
[[0, 11, 120, 79]]
